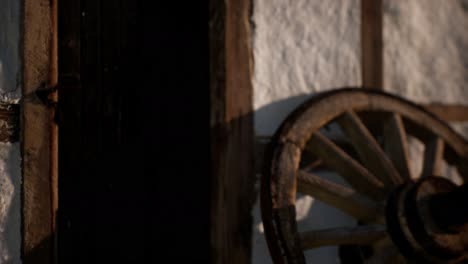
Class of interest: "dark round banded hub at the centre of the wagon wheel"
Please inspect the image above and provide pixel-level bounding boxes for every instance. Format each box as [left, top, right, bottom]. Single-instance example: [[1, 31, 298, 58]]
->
[[386, 177, 468, 263]]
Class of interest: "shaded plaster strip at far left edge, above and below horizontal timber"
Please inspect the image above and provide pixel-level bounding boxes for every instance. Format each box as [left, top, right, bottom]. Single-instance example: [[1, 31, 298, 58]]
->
[[0, 0, 21, 263]]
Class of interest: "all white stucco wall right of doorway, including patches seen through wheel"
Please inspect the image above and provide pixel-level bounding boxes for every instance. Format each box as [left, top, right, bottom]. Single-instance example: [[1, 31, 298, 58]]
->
[[252, 0, 468, 264]]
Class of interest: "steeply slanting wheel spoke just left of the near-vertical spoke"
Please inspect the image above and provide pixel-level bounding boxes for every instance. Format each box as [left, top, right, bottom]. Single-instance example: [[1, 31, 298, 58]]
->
[[337, 111, 402, 188]]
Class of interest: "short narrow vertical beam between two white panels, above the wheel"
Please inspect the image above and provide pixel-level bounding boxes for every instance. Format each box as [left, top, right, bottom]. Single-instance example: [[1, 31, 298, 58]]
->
[[361, 0, 383, 90]]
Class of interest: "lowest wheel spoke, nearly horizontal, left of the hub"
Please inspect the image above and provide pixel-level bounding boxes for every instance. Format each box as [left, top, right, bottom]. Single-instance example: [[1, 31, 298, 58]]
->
[[299, 225, 386, 249]]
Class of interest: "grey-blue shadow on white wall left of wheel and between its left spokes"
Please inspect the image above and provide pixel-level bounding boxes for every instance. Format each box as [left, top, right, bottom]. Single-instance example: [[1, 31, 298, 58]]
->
[[252, 93, 355, 264]]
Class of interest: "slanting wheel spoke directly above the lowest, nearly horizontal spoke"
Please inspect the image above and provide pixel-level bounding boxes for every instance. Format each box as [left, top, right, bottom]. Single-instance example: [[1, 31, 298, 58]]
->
[[297, 171, 383, 221]]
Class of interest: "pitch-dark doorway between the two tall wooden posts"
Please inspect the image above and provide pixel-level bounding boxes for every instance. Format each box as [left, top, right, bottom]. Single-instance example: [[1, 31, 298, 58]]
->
[[57, 0, 209, 263]]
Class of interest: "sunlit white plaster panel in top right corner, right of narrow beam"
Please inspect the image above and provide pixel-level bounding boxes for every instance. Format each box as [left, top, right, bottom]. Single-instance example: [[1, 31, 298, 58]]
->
[[383, 0, 468, 104]]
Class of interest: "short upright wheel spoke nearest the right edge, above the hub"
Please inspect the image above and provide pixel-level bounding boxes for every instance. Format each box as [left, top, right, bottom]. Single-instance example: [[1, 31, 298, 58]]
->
[[421, 137, 445, 177]]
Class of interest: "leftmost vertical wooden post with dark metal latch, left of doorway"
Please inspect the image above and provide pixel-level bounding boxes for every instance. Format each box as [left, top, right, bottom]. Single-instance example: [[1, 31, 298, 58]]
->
[[21, 0, 56, 264]]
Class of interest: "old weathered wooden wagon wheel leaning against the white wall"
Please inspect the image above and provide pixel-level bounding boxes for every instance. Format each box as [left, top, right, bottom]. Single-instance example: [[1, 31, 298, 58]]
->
[[261, 88, 468, 264]]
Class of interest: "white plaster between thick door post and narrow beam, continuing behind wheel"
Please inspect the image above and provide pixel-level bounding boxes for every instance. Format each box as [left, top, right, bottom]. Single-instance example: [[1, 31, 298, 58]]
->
[[252, 0, 361, 264]]
